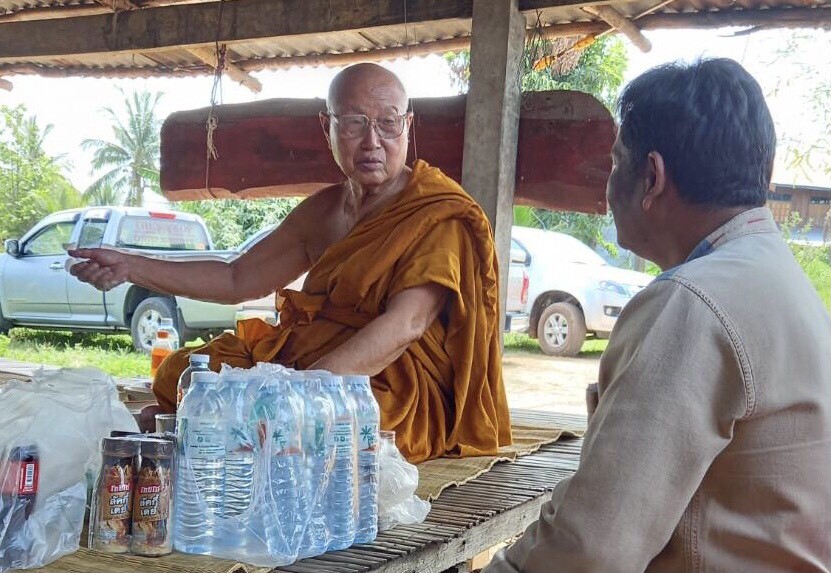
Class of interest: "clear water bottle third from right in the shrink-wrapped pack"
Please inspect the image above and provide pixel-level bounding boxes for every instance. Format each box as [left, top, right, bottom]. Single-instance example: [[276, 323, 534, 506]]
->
[[298, 373, 335, 558]]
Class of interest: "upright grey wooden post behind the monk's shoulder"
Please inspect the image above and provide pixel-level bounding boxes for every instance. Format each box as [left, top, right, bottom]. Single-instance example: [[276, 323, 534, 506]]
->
[[462, 0, 525, 340]]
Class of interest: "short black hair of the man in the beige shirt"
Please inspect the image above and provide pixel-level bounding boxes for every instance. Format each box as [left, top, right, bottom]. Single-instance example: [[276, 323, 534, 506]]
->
[[618, 58, 776, 207]]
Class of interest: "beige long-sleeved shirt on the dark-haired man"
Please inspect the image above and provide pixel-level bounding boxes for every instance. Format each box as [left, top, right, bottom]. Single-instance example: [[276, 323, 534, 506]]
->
[[486, 208, 831, 573]]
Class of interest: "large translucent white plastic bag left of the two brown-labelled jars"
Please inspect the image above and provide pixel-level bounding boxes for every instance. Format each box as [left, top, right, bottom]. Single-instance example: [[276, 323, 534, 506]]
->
[[0, 368, 138, 573]]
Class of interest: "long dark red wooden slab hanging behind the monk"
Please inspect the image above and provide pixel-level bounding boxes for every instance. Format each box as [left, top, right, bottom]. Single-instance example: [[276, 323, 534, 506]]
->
[[161, 91, 614, 213]]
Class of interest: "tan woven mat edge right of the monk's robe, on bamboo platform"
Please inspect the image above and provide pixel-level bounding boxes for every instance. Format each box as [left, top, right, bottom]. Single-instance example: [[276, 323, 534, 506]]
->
[[416, 410, 586, 500]]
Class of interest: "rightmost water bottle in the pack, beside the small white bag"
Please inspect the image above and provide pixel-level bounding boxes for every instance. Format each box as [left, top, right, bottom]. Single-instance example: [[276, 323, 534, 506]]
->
[[344, 376, 381, 543]]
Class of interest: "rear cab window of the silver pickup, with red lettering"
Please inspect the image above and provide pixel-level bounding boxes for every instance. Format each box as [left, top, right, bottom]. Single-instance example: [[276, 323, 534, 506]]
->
[[116, 215, 208, 251]]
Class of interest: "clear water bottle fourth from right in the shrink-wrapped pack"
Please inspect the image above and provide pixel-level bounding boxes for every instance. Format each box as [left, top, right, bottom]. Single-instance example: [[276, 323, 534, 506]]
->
[[254, 376, 307, 556]]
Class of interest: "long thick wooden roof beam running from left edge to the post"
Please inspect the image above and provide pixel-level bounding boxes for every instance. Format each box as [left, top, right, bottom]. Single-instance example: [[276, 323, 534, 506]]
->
[[0, 0, 478, 58]]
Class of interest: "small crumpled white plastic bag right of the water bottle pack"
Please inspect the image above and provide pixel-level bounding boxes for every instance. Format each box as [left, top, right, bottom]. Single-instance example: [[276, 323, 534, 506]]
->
[[378, 432, 430, 531]]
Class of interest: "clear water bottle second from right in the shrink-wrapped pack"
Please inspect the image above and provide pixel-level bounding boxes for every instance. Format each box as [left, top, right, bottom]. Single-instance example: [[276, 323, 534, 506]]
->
[[313, 371, 357, 551]]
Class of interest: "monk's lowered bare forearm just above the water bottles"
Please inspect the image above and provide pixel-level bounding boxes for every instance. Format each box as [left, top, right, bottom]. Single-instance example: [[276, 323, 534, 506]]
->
[[312, 283, 448, 376]]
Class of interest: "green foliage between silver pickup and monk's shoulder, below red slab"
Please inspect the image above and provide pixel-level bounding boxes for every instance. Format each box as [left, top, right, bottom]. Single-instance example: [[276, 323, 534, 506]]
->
[[175, 198, 300, 249]]
